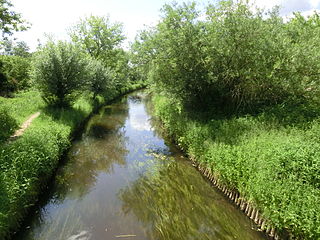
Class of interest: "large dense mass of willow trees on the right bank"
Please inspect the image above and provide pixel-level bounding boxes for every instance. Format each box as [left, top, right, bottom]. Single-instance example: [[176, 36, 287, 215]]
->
[[133, 1, 320, 113]]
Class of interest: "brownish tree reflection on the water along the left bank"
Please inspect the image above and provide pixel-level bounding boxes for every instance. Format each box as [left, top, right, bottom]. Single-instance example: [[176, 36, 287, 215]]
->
[[54, 103, 128, 201]]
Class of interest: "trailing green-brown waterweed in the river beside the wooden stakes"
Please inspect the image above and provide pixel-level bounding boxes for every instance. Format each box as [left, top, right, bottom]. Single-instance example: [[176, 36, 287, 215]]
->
[[119, 154, 259, 240]]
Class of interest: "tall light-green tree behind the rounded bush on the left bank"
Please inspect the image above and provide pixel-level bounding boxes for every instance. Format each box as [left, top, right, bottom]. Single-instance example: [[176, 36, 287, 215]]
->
[[70, 16, 130, 88]]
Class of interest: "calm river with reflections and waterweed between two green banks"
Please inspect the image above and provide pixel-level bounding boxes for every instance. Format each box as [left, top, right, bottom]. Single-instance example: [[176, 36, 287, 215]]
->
[[15, 91, 266, 240]]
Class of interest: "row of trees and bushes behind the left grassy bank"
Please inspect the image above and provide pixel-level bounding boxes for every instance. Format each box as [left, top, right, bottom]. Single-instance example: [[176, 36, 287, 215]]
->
[[0, 16, 141, 106]]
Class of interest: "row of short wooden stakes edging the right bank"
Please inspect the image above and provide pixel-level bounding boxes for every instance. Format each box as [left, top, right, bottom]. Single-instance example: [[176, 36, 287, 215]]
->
[[192, 160, 280, 240]]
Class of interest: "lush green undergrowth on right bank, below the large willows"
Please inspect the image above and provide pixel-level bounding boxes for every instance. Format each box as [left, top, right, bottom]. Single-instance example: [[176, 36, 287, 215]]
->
[[153, 96, 320, 239]]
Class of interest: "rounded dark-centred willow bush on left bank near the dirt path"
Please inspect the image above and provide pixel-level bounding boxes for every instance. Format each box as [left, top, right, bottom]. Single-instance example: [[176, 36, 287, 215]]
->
[[32, 41, 88, 107]]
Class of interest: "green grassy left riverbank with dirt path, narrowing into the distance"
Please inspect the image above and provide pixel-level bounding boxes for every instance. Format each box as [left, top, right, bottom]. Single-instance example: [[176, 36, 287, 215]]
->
[[0, 84, 142, 239]]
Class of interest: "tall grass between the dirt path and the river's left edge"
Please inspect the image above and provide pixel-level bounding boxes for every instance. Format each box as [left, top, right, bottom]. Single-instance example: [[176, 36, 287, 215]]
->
[[0, 113, 77, 238]]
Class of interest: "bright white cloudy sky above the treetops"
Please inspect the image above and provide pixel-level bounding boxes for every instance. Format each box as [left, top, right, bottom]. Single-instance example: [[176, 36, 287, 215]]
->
[[11, 0, 320, 50]]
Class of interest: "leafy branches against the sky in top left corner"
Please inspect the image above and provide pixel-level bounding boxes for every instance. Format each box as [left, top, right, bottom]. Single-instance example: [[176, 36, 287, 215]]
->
[[0, 0, 28, 37]]
